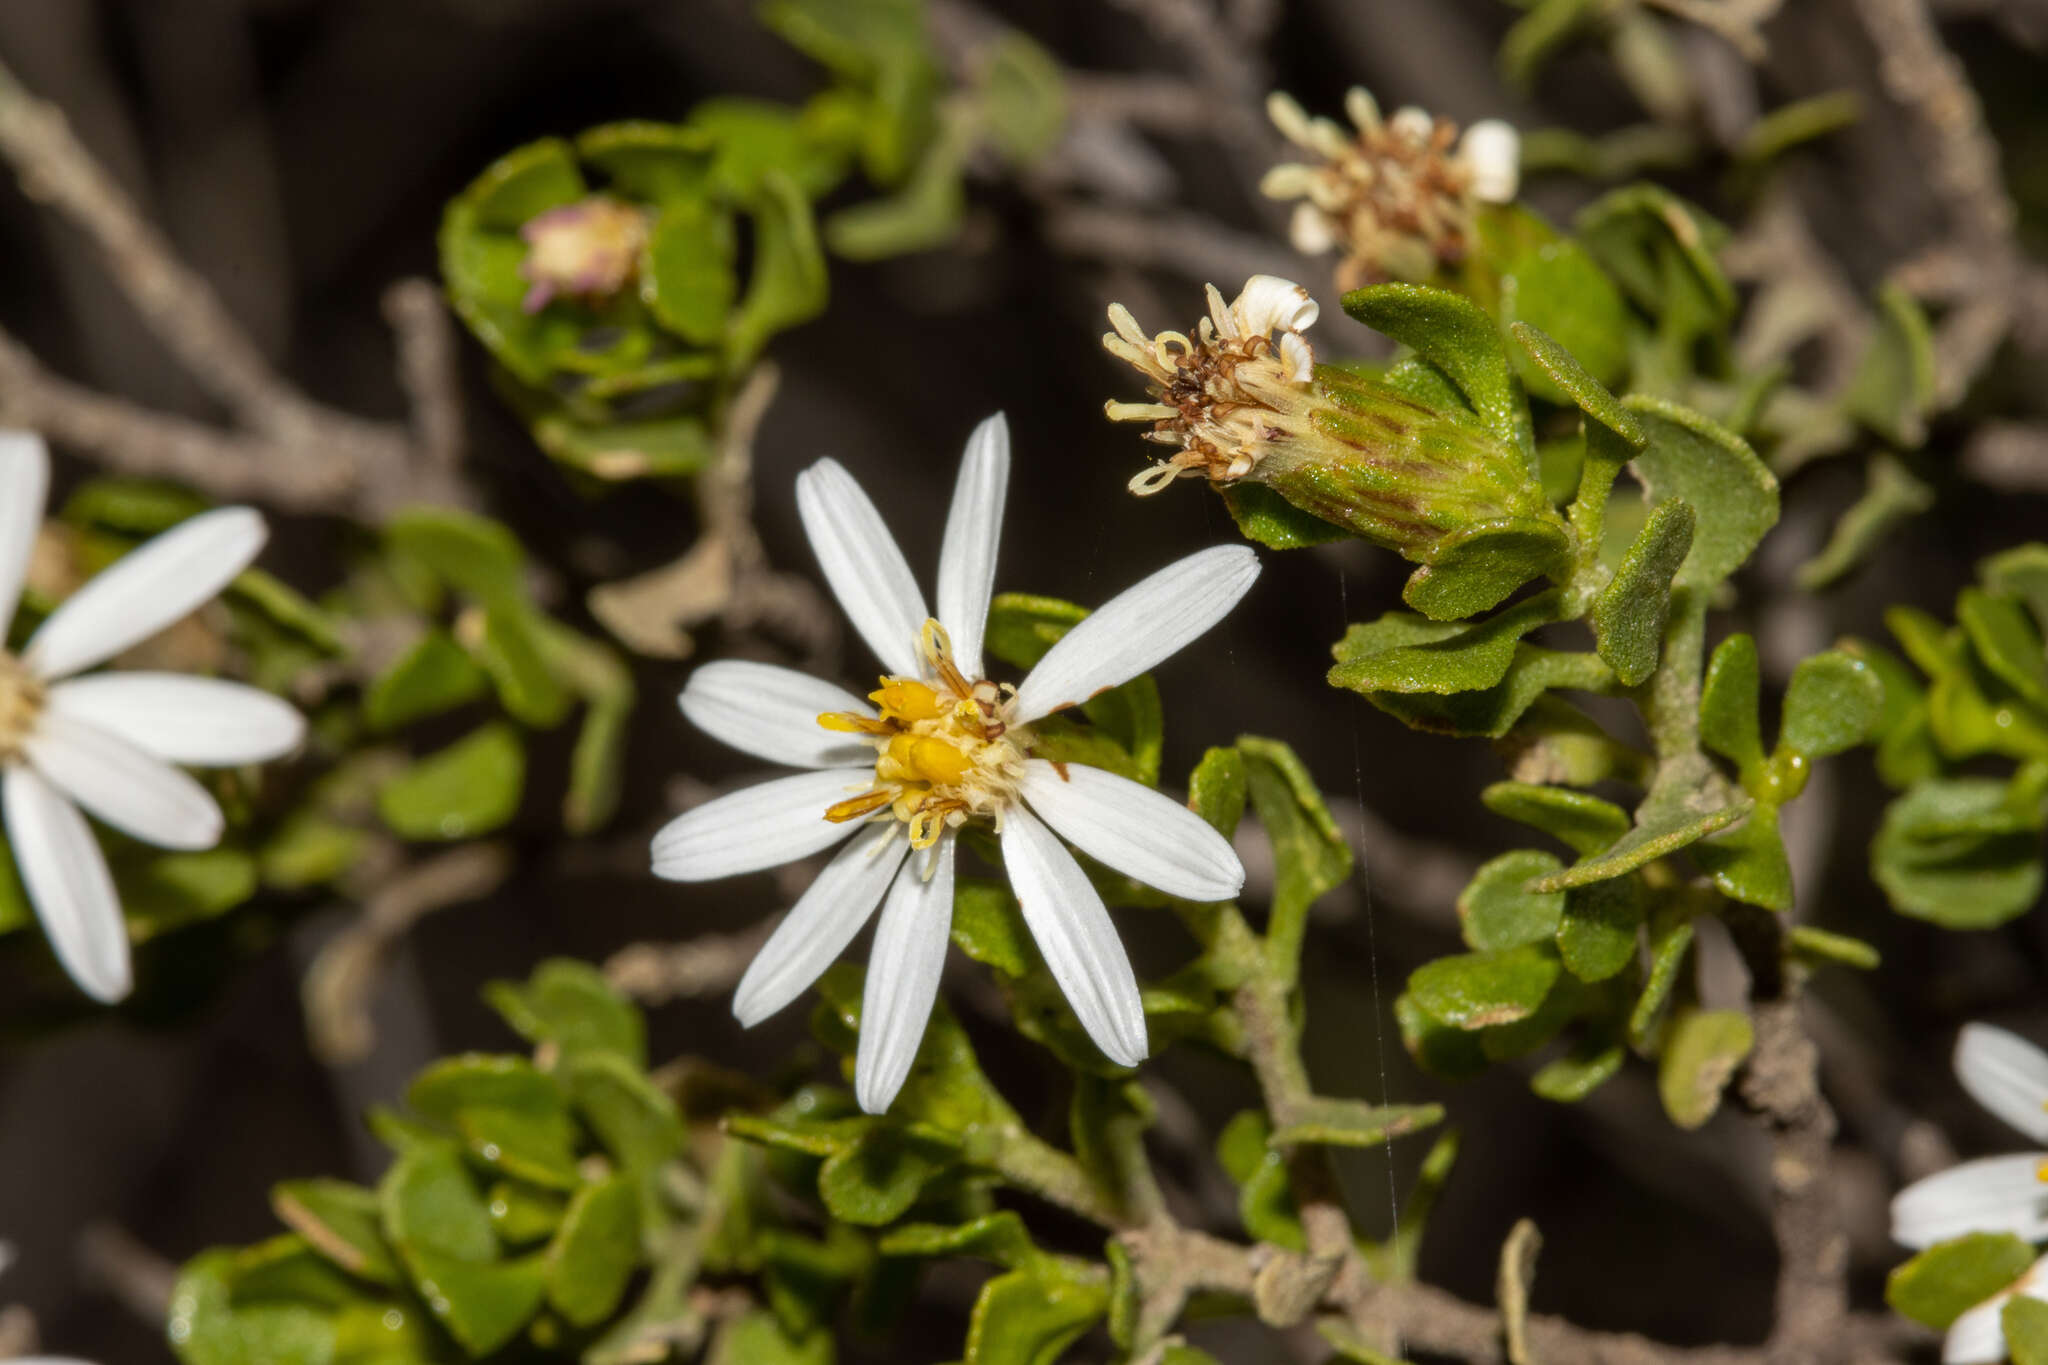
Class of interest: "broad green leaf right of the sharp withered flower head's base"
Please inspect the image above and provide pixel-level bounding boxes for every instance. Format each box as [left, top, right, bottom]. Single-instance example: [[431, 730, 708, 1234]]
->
[[1624, 393, 1778, 587]]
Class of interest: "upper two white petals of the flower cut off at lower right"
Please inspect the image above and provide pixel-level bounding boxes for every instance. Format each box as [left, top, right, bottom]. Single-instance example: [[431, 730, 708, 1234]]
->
[[1892, 1023, 2048, 1250]]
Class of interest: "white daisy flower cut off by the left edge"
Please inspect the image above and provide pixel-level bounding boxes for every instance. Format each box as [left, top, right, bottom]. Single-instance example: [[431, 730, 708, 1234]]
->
[[0, 432, 305, 1003]]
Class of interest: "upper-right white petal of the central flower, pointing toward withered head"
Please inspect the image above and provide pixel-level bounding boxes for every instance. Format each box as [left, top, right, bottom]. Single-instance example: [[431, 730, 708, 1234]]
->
[[1016, 544, 1260, 724]]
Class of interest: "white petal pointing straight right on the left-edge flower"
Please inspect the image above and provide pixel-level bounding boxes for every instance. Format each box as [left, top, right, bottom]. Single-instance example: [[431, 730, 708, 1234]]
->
[[49, 673, 305, 767]]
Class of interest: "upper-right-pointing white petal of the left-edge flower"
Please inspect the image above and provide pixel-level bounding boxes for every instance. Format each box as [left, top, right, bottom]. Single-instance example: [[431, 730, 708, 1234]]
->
[[23, 508, 270, 677]]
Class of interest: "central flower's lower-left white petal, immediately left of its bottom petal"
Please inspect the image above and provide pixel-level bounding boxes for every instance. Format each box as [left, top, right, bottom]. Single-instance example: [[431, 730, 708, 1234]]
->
[[733, 821, 909, 1027]]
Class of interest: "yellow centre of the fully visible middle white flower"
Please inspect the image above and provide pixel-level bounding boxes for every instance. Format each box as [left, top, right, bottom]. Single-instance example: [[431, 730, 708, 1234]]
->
[[817, 620, 1030, 849]]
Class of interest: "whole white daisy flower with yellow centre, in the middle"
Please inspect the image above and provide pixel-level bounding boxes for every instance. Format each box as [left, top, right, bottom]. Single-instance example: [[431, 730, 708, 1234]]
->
[[653, 413, 1260, 1113]]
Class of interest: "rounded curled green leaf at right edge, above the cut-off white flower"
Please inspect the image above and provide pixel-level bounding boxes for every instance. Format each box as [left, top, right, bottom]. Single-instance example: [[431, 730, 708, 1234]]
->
[[1870, 778, 2042, 929]]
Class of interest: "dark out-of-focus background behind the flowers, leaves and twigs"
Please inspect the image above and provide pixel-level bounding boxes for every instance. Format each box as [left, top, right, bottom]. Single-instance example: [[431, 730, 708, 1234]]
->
[[0, 0, 2048, 1363]]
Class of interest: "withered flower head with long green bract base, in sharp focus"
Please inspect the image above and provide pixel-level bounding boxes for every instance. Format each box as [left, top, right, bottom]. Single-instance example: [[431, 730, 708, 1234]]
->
[[1102, 276, 1565, 563]]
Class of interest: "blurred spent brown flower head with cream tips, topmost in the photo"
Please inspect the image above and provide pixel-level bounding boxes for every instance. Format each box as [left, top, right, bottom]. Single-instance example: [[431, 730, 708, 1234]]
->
[[1260, 86, 1522, 289]]
